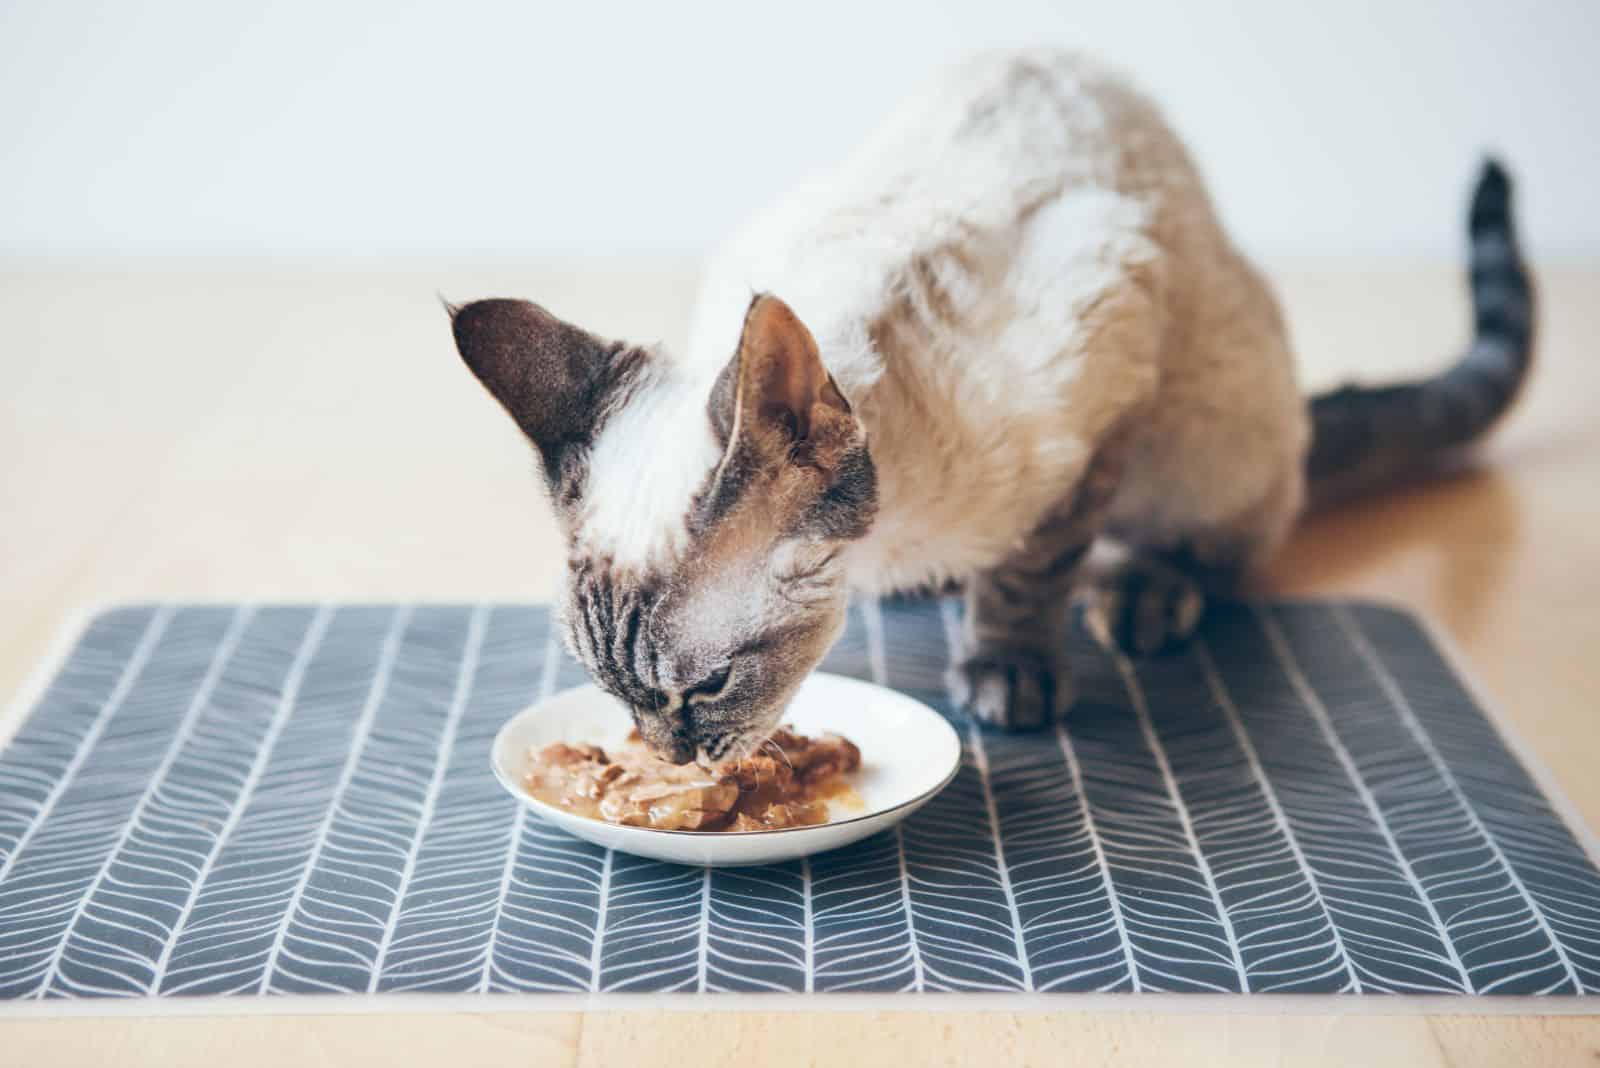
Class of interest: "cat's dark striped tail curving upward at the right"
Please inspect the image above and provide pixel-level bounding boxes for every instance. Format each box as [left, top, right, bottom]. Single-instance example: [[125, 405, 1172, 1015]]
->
[[1306, 160, 1534, 507]]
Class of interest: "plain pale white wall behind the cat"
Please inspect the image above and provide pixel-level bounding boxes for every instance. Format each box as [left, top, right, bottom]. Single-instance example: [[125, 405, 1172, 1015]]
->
[[0, 0, 1600, 256]]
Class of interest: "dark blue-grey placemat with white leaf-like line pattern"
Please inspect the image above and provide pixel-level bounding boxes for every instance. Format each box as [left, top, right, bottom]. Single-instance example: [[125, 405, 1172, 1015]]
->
[[0, 601, 1600, 1004]]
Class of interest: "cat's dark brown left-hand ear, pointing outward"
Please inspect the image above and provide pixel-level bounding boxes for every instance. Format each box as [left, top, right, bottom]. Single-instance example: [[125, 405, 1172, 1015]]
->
[[445, 299, 643, 496]]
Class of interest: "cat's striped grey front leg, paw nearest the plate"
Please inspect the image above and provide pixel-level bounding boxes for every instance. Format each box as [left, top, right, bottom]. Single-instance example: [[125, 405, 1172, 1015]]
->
[[949, 451, 1122, 729]]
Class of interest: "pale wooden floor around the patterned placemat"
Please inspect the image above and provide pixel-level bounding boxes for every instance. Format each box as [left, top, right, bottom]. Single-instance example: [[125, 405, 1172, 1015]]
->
[[0, 262, 1600, 1068]]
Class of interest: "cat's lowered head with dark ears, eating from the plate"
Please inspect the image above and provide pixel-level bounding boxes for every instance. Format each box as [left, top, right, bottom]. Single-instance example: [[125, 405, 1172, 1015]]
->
[[451, 287, 877, 763]]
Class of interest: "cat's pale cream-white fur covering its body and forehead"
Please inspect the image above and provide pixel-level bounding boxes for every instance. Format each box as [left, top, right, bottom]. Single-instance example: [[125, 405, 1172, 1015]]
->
[[589, 51, 1307, 590]]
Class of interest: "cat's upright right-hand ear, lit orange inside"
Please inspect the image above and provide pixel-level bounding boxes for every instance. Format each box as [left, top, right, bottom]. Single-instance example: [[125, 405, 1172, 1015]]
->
[[710, 294, 858, 462]]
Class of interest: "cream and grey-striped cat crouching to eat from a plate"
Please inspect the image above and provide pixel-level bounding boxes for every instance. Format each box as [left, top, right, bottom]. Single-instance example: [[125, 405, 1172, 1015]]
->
[[450, 51, 1533, 763]]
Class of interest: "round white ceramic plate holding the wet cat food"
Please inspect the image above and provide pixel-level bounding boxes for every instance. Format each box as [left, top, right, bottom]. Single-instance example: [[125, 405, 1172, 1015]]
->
[[490, 673, 962, 867]]
